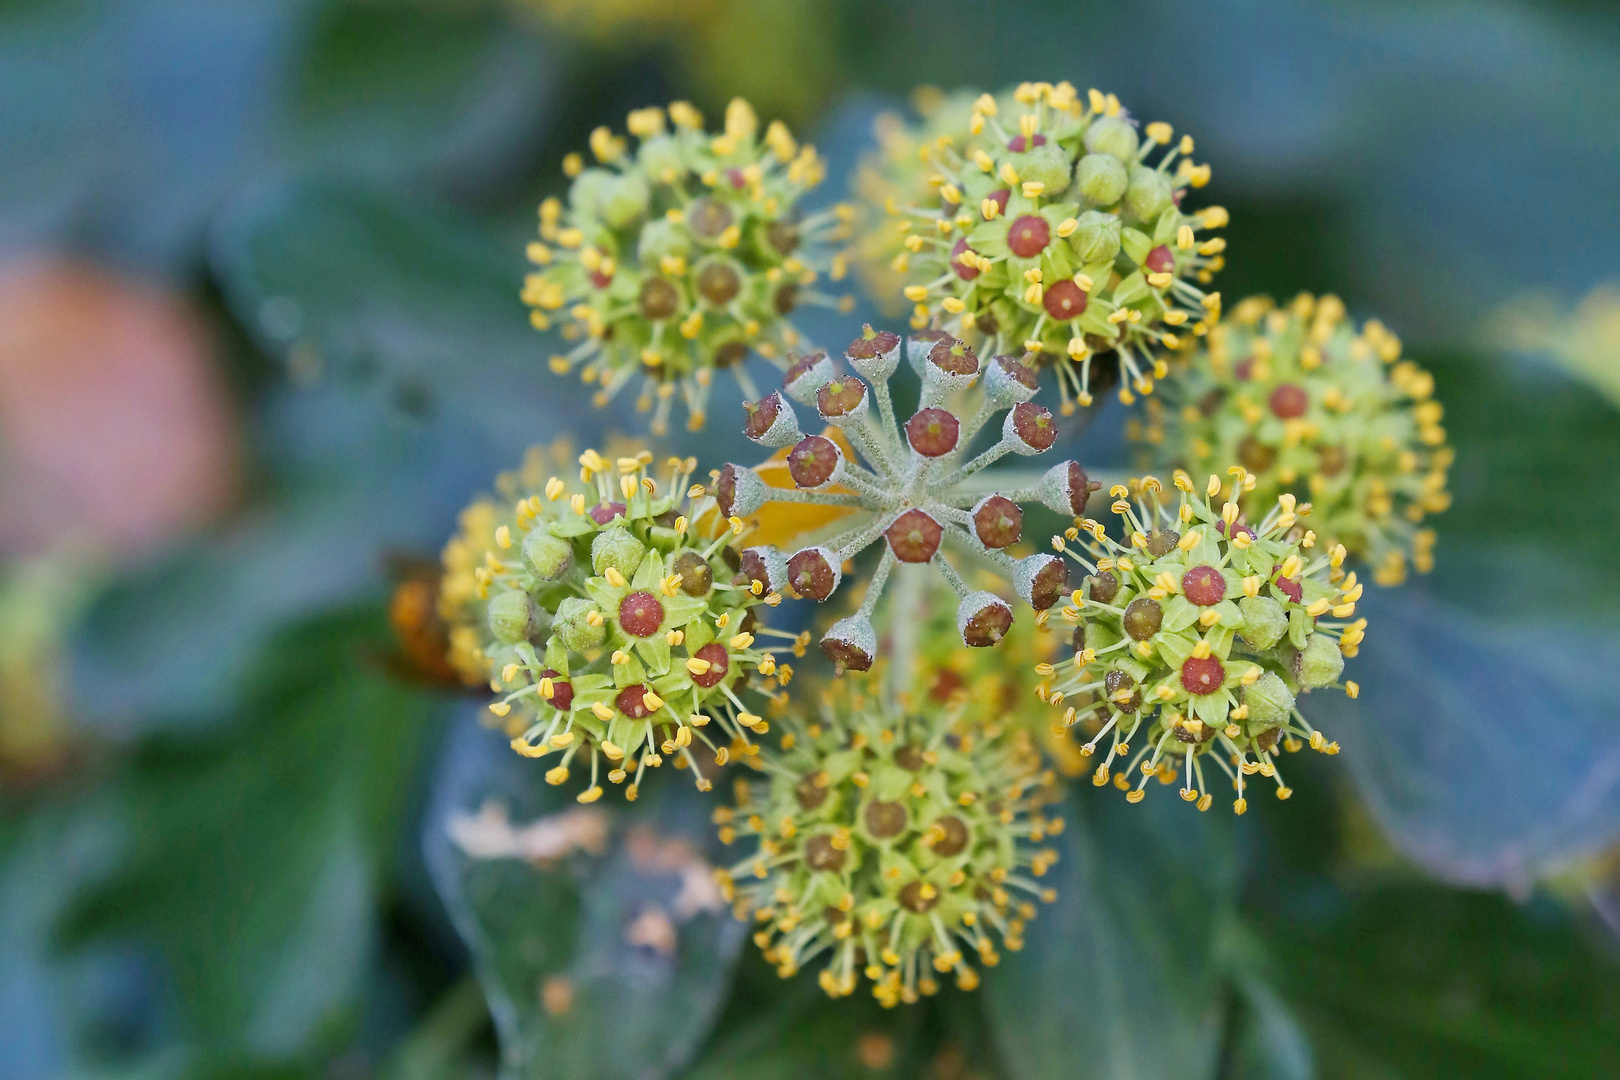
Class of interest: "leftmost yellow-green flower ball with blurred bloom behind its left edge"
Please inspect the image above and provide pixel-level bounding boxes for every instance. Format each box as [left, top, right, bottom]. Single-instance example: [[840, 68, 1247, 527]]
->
[[442, 450, 808, 801]]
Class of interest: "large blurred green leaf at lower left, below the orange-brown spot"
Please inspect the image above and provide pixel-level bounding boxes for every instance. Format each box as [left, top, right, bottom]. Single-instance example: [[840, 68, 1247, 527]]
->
[[62, 610, 429, 1056]]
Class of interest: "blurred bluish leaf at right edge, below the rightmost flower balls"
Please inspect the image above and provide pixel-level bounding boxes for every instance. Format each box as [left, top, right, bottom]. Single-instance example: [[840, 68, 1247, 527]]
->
[[1307, 573, 1620, 889]]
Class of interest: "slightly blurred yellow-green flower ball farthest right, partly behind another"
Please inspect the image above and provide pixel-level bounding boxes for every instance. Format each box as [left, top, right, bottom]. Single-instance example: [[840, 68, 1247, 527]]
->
[[1132, 295, 1453, 585]]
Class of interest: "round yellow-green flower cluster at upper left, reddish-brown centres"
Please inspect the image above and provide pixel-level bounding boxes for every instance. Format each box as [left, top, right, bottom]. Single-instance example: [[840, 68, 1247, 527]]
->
[[523, 99, 849, 434]]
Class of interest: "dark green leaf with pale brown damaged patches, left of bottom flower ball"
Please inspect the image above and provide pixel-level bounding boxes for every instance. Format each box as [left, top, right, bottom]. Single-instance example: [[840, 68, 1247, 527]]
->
[[424, 714, 747, 1080]]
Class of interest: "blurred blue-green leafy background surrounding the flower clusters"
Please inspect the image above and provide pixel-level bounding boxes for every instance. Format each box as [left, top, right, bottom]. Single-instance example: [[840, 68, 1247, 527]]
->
[[0, 0, 1620, 1080]]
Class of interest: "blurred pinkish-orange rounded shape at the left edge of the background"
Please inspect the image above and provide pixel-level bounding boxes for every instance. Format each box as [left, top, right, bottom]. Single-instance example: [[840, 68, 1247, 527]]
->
[[0, 257, 238, 555]]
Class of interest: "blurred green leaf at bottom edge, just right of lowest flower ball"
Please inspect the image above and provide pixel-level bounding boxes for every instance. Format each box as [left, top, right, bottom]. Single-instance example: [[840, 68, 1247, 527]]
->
[[983, 789, 1238, 1080]]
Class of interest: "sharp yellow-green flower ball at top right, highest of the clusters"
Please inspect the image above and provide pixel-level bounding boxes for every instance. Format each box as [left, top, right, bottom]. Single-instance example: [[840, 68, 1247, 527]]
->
[[862, 83, 1226, 413]]
